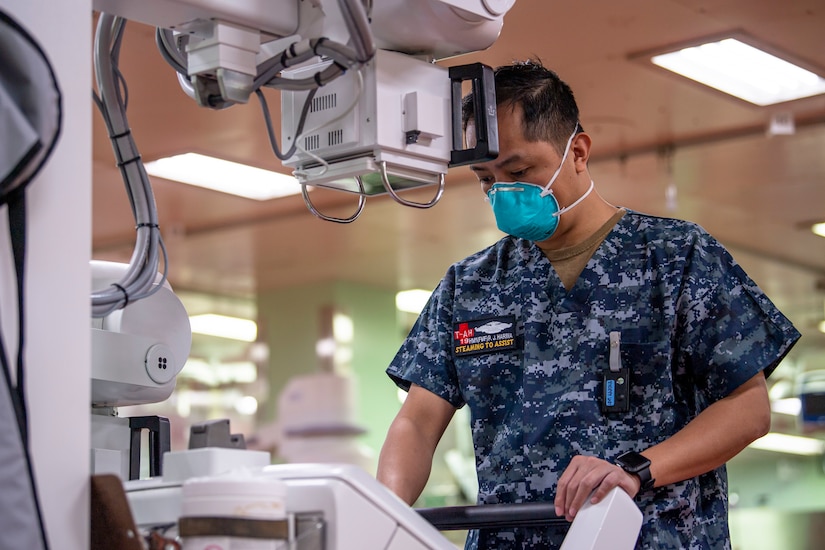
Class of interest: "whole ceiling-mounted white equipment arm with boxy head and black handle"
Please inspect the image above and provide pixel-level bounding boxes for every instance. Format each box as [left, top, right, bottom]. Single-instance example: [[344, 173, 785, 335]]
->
[[94, 0, 515, 223]]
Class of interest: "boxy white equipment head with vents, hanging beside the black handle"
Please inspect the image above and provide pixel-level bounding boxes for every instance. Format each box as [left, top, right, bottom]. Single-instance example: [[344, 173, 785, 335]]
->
[[281, 50, 453, 195]]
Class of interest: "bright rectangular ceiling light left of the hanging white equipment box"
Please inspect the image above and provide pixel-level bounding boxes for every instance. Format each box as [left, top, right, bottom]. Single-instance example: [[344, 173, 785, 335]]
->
[[145, 153, 301, 201]]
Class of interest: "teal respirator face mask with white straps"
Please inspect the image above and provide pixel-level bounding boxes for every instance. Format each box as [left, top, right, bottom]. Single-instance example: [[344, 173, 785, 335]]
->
[[487, 130, 593, 241]]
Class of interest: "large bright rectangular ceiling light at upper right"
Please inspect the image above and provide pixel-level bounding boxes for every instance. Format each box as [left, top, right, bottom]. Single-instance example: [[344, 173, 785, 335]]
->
[[650, 38, 825, 106]]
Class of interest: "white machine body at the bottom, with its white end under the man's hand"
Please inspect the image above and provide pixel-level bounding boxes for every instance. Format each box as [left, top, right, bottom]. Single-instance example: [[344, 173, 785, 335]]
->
[[125, 449, 642, 550]]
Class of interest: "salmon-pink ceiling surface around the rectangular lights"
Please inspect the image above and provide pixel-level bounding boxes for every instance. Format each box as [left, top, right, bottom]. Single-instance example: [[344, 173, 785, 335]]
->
[[94, 0, 825, 367]]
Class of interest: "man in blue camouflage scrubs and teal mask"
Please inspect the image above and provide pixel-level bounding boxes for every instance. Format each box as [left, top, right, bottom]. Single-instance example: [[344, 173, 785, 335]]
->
[[378, 62, 800, 550]]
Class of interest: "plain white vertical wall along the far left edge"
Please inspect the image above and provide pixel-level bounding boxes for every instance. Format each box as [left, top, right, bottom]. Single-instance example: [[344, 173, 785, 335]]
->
[[0, 0, 92, 550]]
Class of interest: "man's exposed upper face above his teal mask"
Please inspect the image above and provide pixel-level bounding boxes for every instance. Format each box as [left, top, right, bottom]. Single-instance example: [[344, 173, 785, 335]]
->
[[467, 106, 561, 194]]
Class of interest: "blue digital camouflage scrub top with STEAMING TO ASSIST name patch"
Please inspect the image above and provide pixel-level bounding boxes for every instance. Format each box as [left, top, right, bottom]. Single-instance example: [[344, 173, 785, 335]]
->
[[387, 210, 800, 550]]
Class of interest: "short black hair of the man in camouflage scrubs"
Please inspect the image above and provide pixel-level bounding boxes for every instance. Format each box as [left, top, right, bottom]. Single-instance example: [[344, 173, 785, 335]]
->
[[462, 59, 584, 150]]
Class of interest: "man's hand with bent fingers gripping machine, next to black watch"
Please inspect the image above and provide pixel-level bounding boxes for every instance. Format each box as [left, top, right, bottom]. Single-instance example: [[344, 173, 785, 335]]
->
[[554, 455, 642, 521]]
